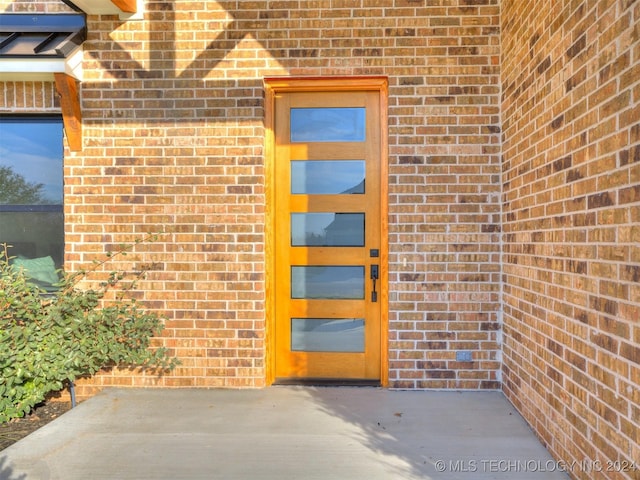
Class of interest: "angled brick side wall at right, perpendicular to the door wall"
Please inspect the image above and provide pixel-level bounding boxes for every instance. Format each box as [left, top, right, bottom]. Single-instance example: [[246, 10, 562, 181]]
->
[[501, 0, 640, 479]]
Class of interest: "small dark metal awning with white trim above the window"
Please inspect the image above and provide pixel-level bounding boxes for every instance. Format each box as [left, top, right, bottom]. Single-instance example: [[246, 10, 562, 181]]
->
[[0, 14, 87, 81]]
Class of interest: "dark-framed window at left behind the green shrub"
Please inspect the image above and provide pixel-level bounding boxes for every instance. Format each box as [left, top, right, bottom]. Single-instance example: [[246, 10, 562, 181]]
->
[[0, 116, 64, 288]]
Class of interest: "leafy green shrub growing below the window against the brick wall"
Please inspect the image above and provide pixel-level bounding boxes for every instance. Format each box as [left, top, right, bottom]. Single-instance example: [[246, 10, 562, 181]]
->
[[0, 238, 178, 423]]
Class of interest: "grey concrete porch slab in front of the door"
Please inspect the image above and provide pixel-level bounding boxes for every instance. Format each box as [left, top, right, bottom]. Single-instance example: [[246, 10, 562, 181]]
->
[[0, 387, 568, 480]]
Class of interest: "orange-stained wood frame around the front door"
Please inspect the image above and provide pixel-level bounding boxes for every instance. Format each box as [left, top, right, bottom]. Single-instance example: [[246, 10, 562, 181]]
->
[[264, 76, 389, 387]]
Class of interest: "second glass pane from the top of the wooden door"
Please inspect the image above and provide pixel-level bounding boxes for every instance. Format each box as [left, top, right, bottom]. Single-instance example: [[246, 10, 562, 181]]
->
[[291, 160, 365, 195]]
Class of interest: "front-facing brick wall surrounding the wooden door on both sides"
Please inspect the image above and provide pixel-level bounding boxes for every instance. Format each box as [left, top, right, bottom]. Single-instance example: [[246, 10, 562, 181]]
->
[[1, 0, 501, 395]]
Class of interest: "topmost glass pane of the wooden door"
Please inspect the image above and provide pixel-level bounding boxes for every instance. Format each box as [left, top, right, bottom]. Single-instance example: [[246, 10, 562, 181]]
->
[[290, 107, 365, 143]]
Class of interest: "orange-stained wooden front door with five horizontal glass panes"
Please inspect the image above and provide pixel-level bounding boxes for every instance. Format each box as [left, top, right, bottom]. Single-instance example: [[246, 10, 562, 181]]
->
[[273, 79, 386, 382]]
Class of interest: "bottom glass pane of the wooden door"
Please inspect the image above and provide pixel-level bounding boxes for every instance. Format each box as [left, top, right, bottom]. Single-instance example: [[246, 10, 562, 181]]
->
[[291, 318, 364, 352]]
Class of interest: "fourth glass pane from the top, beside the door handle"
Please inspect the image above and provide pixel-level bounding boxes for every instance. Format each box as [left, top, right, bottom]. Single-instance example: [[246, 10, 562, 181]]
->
[[291, 265, 364, 299]]
